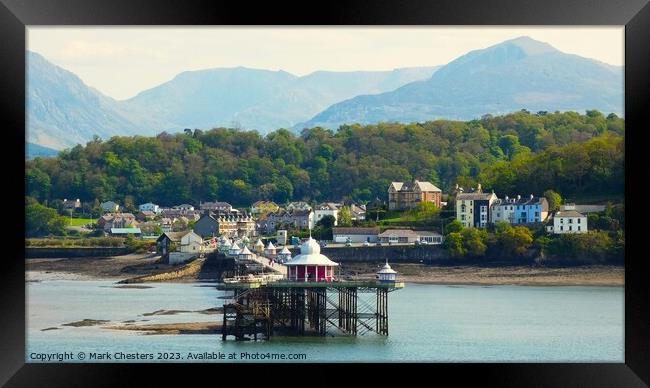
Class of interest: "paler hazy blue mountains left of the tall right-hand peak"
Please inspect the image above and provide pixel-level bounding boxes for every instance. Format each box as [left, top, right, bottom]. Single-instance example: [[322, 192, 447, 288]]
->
[[27, 52, 437, 149]]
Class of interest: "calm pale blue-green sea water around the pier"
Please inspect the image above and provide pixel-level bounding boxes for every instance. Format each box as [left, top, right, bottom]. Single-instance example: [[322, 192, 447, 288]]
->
[[26, 280, 624, 362]]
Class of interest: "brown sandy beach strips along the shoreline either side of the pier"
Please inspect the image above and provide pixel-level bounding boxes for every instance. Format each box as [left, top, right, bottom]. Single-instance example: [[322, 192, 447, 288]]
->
[[26, 254, 625, 286]]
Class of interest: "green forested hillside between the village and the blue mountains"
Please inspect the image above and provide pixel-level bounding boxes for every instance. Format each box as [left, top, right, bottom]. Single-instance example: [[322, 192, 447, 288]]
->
[[26, 111, 625, 206]]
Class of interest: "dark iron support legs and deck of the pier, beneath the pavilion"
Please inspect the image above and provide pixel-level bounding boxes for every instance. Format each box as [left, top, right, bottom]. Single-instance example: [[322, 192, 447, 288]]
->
[[222, 280, 404, 340]]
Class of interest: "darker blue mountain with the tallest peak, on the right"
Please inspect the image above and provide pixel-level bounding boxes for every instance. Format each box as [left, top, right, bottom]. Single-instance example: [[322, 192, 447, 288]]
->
[[296, 37, 624, 129]]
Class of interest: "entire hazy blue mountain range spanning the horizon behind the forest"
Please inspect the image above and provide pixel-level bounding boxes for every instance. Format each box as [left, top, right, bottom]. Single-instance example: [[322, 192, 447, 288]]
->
[[26, 37, 623, 149]]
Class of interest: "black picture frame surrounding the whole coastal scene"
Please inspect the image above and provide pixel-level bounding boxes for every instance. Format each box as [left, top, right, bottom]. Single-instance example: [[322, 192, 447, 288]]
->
[[0, 0, 650, 386]]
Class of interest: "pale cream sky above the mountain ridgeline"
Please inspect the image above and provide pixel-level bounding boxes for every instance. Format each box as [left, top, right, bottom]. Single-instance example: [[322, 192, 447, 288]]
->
[[27, 26, 625, 100]]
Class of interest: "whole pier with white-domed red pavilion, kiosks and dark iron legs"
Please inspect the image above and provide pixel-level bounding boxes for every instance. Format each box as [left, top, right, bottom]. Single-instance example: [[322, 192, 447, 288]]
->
[[221, 233, 404, 340]]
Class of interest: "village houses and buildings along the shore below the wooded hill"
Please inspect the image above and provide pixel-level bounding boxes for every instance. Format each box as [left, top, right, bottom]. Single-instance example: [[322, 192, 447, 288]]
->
[[44, 180, 605, 265]]
